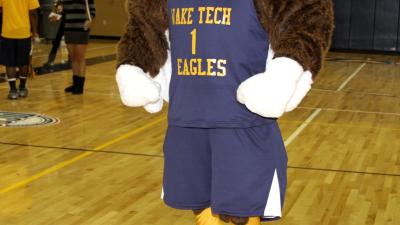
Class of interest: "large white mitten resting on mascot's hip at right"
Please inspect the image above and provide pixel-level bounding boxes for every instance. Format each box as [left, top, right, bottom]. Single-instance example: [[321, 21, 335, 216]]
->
[[237, 57, 304, 118]]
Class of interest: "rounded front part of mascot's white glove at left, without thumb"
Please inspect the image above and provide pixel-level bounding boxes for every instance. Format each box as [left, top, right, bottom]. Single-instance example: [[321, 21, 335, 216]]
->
[[116, 65, 161, 107]]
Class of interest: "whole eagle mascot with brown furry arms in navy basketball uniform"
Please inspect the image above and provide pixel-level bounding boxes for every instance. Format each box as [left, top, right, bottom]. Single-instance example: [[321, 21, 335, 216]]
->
[[116, 0, 333, 225]]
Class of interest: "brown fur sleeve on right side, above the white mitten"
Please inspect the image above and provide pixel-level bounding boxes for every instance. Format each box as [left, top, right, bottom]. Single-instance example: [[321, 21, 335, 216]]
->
[[254, 0, 334, 76]]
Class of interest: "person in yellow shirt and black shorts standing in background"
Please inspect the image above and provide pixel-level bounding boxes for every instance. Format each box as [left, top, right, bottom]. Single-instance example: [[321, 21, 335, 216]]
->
[[0, 0, 40, 100]]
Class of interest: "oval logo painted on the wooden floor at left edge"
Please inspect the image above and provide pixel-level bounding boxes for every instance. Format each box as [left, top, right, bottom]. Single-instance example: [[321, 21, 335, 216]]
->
[[0, 111, 60, 127]]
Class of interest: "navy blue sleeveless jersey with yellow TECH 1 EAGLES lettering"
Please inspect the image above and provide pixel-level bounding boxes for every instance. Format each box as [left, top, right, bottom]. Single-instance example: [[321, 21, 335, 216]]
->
[[168, 0, 269, 128]]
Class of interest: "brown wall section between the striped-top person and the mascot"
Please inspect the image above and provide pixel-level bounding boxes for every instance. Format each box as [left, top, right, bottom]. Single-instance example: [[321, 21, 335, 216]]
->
[[91, 0, 127, 37]]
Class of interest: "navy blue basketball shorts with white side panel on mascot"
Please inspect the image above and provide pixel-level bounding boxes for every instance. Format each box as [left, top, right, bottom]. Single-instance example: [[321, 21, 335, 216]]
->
[[163, 120, 287, 220]]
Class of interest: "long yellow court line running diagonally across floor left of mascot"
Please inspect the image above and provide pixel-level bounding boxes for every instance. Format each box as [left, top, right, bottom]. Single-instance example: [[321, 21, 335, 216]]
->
[[0, 117, 165, 195]]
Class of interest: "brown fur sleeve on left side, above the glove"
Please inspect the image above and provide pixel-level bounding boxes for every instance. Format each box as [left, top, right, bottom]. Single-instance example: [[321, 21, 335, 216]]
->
[[117, 0, 168, 77]]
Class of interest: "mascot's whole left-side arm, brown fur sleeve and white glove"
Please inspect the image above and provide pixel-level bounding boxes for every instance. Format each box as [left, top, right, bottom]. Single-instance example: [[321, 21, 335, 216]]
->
[[116, 0, 171, 113]]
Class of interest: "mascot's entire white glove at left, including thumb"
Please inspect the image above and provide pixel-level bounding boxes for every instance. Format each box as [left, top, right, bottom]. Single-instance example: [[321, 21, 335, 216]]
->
[[116, 53, 172, 113]]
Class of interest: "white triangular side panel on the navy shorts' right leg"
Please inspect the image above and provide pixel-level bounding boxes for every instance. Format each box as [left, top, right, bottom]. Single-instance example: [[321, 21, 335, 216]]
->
[[264, 169, 282, 218]]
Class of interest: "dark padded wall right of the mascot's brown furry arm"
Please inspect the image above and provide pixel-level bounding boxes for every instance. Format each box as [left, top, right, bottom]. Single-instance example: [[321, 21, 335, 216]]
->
[[332, 0, 400, 52]]
